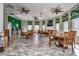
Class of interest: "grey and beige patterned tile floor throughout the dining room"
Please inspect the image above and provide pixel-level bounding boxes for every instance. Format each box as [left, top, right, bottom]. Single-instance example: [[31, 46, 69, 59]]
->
[[0, 35, 76, 56]]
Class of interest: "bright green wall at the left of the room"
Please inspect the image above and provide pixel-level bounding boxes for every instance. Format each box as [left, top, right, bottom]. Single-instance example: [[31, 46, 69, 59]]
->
[[8, 16, 21, 29]]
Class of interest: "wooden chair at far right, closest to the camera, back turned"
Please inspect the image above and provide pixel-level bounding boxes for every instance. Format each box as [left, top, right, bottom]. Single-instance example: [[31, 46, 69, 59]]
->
[[63, 31, 76, 53]]
